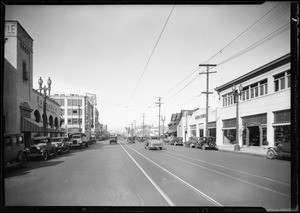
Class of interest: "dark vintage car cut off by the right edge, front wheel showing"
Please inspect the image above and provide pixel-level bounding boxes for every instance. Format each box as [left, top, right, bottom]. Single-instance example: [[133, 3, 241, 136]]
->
[[267, 140, 291, 159]]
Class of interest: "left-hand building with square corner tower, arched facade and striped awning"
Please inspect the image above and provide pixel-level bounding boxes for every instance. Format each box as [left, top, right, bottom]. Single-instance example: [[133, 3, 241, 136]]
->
[[2, 21, 63, 146]]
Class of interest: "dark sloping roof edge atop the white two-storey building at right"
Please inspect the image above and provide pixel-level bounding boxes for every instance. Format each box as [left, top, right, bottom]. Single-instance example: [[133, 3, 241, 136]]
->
[[215, 53, 291, 92]]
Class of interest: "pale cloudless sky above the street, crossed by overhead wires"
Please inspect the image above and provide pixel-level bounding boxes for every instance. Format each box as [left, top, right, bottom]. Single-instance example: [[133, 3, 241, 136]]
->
[[5, 2, 290, 131]]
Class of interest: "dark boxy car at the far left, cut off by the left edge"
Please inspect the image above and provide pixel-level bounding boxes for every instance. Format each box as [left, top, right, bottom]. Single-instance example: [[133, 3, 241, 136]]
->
[[4, 134, 29, 168]]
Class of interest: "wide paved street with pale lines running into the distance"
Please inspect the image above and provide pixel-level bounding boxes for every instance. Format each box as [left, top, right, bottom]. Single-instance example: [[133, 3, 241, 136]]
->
[[5, 140, 291, 211]]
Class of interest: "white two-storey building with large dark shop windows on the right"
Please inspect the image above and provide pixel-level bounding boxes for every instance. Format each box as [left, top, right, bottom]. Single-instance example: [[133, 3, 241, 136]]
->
[[215, 54, 291, 148]]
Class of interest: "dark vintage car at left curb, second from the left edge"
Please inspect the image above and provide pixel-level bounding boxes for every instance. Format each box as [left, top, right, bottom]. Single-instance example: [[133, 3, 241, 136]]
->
[[27, 136, 57, 160]]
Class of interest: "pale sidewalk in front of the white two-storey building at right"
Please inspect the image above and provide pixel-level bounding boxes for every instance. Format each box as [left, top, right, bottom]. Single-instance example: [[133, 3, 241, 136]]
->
[[218, 145, 268, 157]]
